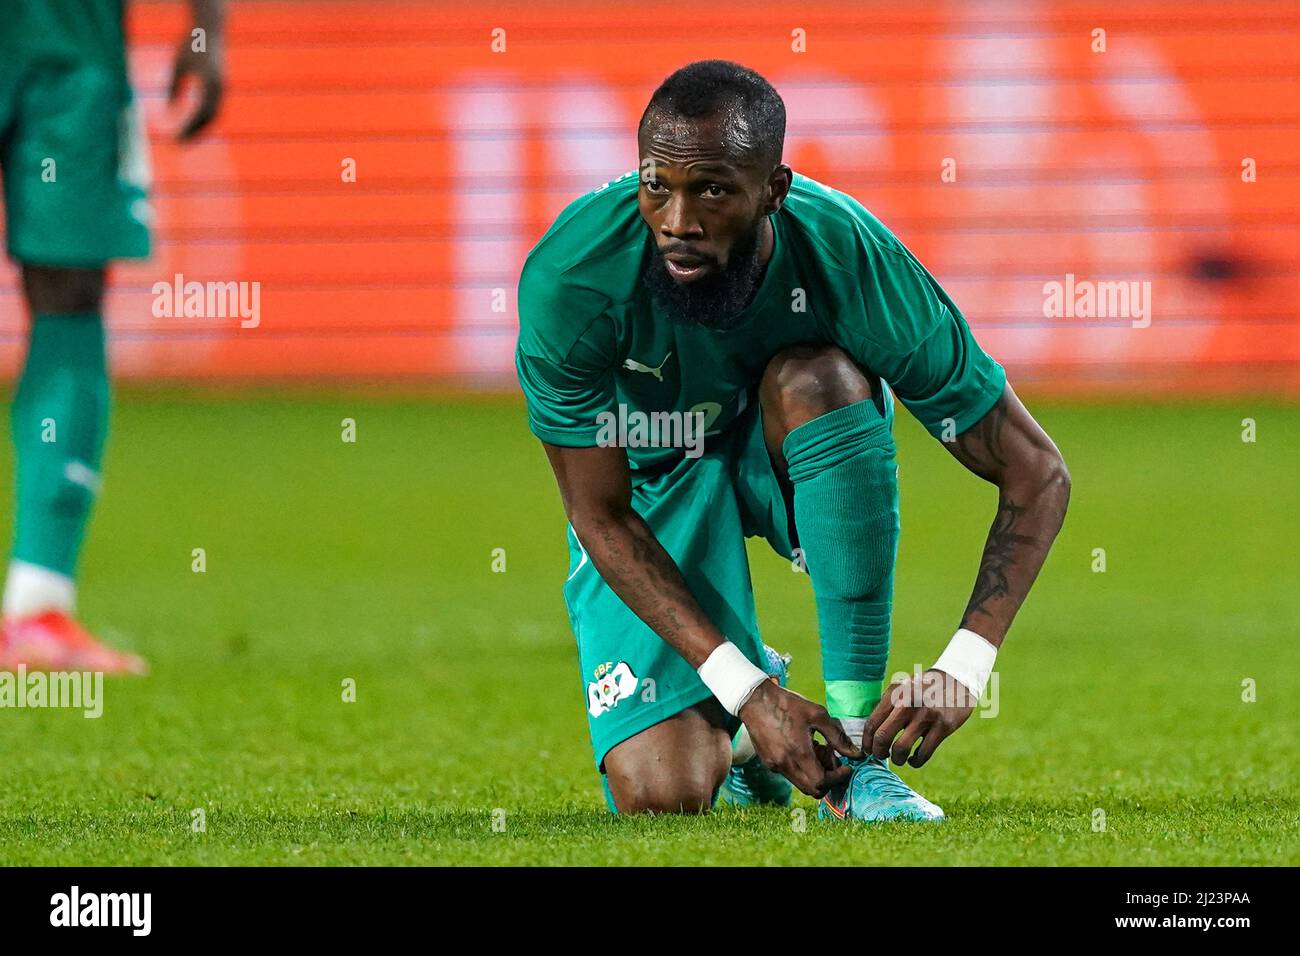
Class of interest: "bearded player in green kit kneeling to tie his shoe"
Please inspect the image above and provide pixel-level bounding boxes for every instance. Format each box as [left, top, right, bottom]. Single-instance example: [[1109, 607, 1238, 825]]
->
[[516, 60, 1070, 821]]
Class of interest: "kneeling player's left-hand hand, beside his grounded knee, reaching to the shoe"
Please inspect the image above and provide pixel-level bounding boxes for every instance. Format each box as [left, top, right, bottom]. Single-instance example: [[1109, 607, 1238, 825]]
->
[[740, 680, 862, 799]]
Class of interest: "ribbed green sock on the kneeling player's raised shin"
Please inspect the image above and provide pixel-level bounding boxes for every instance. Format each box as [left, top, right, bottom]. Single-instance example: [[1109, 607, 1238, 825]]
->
[[784, 399, 898, 718]]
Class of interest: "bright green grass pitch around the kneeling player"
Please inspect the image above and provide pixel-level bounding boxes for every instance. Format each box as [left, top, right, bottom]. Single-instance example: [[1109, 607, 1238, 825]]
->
[[0, 393, 1300, 865]]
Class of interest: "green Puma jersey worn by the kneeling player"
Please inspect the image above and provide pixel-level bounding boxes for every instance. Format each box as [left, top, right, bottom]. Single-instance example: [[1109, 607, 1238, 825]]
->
[[515, 172, 1006, 470]]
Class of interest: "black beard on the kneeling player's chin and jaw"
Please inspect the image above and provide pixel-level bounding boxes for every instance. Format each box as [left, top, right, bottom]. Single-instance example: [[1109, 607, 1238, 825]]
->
[[644, 217, 763, 332]]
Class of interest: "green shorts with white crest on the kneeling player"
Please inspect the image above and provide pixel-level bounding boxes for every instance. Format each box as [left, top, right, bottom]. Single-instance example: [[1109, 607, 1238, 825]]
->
[[564, 405, 794, 771]]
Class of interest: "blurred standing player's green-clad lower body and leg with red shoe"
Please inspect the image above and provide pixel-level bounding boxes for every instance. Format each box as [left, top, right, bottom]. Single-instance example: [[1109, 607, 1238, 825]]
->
[[0, 1, 150, 672]]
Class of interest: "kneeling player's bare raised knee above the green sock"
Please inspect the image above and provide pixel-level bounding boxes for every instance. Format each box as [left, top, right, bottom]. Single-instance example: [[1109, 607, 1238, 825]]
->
[[758, 345, 876, 432]]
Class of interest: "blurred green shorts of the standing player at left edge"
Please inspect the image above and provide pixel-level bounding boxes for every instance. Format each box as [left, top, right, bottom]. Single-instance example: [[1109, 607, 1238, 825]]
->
[[0, 56, 151, 267]]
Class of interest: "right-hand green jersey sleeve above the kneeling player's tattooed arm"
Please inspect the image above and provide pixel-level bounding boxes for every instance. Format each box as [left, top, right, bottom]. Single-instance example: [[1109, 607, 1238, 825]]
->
[[854, 231, 1006, 438]]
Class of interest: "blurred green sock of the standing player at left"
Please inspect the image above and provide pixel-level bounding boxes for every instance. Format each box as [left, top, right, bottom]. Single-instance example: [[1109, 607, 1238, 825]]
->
[[12, 312, 108, 578]]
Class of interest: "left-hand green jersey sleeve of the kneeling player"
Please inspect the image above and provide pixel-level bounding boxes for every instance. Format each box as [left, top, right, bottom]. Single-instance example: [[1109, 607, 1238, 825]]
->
[[515, 254, 616, 447]]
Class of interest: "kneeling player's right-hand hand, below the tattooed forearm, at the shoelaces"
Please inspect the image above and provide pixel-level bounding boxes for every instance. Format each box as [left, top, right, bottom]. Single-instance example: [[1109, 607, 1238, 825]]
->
[[863, 670, 979, 767]]
